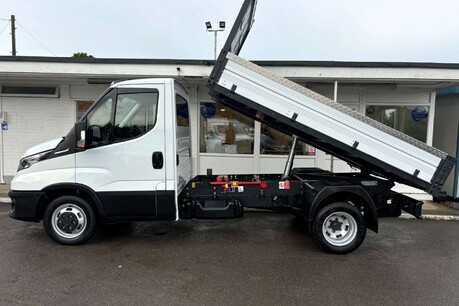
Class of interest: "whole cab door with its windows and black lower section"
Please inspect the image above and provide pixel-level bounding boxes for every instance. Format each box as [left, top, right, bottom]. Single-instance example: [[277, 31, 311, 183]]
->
[[76, 85, 175, 219]]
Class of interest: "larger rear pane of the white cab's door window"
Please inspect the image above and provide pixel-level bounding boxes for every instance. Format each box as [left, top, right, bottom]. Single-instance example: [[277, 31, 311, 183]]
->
[[113, 92, 158, 142]]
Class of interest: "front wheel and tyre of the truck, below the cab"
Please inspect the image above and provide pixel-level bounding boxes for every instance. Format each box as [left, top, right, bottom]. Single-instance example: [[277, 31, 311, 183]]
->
[[43, 196, 96, 245]]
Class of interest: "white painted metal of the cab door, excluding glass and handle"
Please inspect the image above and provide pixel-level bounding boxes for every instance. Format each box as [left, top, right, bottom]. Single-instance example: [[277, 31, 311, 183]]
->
[[76, 80, 167, 192]]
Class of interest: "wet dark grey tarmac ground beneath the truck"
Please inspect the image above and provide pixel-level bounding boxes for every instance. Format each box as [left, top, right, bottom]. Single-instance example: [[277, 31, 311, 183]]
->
[[0, 204, 459, 305]]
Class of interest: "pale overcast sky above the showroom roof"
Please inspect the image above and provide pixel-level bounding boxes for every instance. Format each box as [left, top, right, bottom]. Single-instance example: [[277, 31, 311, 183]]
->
[[0, 0, 459, 63]]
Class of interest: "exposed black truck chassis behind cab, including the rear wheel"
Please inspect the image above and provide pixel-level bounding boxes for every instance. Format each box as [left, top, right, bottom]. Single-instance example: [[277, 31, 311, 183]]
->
[[179, 168, 422, 254]]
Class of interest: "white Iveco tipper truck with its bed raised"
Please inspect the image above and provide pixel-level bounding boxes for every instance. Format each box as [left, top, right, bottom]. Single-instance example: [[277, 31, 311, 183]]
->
[[10, 0, 455, 254]]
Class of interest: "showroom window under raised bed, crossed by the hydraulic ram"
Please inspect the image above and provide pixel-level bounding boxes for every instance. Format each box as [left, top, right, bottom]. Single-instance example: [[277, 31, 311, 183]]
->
[[260, 124, 316, 156]]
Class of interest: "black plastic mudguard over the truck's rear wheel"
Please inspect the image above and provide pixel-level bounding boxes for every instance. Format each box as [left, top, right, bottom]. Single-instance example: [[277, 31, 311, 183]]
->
[[308, 186, 379, 233]]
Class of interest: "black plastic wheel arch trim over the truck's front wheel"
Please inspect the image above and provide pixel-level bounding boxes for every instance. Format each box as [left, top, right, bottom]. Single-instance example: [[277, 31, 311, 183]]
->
[[38, 183, 105, 219]]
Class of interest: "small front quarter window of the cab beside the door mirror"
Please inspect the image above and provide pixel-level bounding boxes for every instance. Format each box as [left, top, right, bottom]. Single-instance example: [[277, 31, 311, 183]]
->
[[87, 94, 114, 147]]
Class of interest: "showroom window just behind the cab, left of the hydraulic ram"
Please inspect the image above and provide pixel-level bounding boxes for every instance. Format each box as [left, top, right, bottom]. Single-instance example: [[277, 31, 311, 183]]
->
[[200, 102, 254, 154]]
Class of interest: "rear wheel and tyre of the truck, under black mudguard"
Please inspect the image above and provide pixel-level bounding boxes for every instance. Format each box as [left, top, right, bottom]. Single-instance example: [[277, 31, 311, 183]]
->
[[312, 202, 366, 254]]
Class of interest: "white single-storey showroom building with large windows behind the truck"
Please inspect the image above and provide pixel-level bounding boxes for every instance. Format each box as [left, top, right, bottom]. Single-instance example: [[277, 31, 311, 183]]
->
[[0, 56, 459, 198]]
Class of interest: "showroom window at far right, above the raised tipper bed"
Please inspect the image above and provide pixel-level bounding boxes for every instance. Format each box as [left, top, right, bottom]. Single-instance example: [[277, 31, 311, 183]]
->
[[365, 105, 429, 142]]
